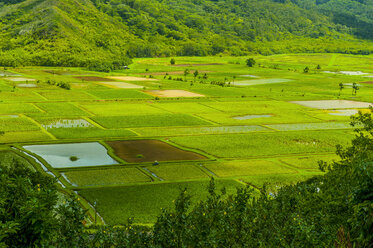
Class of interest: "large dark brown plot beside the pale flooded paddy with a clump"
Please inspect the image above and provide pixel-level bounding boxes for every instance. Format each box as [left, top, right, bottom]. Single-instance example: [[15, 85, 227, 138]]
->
[[106, 140, 207, 163]]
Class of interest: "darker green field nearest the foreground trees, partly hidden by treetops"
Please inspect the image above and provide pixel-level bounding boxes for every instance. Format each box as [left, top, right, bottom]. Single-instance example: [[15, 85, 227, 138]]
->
[[79, 179, 242, 224]]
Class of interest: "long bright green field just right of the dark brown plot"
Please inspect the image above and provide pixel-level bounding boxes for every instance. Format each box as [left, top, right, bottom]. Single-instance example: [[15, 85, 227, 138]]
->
[[170, 130, 353, 158]]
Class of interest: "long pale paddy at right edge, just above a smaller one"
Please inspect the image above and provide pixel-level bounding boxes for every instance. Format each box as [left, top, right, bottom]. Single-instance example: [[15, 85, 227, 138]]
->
[[292, 100, 373, 109]]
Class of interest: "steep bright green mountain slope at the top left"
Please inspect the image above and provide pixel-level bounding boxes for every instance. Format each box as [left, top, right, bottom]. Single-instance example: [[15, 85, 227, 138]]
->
[[0, 0, 136, 66]]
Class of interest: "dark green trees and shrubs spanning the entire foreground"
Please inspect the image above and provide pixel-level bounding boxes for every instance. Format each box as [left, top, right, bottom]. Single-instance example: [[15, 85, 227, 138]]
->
[[0, 109, 373, 247]]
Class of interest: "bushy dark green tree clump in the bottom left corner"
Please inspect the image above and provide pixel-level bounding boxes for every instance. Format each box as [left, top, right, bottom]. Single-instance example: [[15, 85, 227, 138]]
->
[[0, 155, 85, 247]]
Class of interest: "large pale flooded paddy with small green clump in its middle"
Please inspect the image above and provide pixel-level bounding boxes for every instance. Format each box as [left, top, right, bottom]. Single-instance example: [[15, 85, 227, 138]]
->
[[23, 142, 118, 168]]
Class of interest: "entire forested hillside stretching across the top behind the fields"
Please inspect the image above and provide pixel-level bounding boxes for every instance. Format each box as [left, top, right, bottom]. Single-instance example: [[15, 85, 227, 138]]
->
[[0, 0, 373, 66]]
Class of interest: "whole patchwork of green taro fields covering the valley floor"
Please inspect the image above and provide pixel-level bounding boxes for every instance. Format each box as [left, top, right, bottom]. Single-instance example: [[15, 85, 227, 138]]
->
[[0, 54, 373, 225]]
